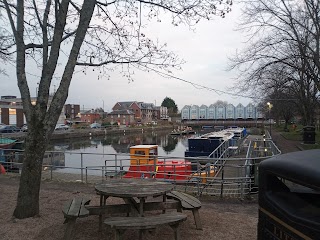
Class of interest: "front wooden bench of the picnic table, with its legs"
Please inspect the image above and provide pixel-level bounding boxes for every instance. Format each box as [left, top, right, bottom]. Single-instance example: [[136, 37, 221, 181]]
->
[[104, 213, 187, 240]]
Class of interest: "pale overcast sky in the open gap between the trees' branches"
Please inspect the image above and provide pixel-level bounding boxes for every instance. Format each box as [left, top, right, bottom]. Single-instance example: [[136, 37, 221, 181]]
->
[[1, 4, 251, 111]]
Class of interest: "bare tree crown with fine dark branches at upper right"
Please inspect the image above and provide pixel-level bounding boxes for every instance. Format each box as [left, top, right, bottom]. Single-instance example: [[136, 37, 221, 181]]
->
[[231, 0, 320, 124]]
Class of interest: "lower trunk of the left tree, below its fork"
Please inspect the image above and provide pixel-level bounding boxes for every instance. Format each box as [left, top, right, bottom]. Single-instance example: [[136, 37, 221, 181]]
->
[[13, 129, 48, 219]]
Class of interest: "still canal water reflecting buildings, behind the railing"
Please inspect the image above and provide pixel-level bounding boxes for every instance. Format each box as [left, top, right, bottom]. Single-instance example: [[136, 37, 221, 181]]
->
[[44, 131, 203, 175]]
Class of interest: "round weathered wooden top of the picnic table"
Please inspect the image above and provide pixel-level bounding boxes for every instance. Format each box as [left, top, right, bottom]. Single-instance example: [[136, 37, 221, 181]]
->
[[95, 178, 173, 198]]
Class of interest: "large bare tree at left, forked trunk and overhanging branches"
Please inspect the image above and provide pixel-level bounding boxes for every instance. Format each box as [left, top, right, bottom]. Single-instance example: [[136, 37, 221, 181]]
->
[[0, 0, 232, 218]]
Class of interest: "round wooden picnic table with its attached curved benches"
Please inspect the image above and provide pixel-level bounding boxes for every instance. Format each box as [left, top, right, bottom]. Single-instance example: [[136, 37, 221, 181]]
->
[[63, 179, 195, 240]]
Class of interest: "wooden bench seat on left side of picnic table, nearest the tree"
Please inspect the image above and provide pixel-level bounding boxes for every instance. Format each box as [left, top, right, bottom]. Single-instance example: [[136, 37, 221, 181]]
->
[[62, 197, 90, 240]]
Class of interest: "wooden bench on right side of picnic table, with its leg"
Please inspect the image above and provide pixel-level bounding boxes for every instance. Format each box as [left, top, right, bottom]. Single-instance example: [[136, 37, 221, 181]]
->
[[166, 191, 202, 230]]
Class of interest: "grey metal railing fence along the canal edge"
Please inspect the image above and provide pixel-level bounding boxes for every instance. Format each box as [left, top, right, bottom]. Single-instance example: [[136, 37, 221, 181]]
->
[[0, 138, 281, 198]]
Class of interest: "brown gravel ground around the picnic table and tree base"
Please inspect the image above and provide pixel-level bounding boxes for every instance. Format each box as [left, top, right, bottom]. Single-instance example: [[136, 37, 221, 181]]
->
[[0, 175, 258, 240]]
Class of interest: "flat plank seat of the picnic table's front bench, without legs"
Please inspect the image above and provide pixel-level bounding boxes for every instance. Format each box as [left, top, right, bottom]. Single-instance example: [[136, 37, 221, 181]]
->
[[104, 213, 187, 229]]
